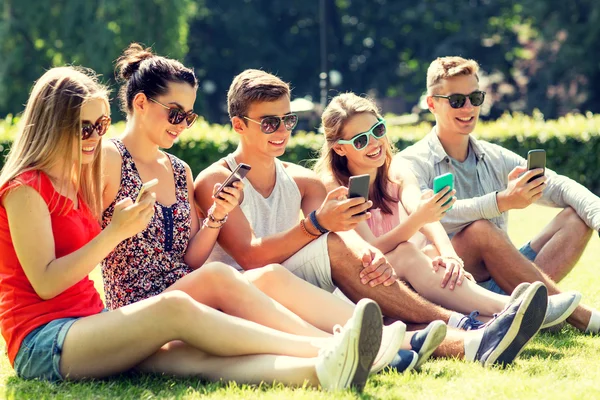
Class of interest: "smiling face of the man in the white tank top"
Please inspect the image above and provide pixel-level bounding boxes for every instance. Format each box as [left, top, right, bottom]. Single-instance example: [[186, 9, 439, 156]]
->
[[232, 96, 292, 157]]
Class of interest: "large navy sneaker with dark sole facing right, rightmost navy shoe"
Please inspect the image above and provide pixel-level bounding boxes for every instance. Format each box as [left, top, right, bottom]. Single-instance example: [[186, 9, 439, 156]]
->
[[475, 282, 548, 367]]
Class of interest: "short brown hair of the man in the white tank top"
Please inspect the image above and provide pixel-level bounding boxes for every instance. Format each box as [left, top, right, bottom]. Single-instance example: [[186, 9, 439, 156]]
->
[[227, 69, 290, 118]]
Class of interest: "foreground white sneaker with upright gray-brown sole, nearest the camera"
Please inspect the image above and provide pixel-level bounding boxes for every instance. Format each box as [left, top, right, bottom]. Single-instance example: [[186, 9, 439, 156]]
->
[[315, 299, 383, 392]]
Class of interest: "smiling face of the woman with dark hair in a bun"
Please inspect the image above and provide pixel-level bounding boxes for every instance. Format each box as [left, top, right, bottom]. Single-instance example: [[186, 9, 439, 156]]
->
[[133, 82, 196, 149]]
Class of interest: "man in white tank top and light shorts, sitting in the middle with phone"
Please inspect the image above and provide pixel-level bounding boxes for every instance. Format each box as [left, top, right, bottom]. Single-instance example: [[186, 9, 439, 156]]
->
[[194, 70, 547, 365]]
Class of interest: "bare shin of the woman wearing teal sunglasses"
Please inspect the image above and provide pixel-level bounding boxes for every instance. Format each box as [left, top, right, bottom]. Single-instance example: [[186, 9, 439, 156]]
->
[[386, 243, 508, 317]]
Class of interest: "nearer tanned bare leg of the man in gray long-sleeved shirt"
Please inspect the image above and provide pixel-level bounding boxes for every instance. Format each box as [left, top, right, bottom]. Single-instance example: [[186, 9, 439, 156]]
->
[[452, 220, 591, 330]]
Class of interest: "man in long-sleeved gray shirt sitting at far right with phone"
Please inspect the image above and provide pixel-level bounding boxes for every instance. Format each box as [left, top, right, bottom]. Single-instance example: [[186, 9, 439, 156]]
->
[[393, 57, 600, 333]]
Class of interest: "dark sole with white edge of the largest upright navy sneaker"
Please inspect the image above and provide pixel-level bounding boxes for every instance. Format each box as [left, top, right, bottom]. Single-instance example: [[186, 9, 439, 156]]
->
[[483, 282, 548, 367]]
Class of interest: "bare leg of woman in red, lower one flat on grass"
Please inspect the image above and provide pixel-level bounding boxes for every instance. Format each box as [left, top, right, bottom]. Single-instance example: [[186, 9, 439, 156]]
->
[[137, 341, 319, 386]]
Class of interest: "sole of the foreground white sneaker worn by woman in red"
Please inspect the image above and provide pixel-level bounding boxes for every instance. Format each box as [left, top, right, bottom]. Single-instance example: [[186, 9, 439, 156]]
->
[[350, 300, 383, 392]]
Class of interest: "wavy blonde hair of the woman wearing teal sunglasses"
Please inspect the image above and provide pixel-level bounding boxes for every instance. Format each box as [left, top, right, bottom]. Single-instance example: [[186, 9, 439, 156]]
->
[[314, 93, 398, 214]]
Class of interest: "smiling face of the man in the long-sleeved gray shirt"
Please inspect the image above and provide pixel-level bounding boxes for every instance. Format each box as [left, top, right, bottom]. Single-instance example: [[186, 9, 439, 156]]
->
[[427, 75, 481, 136]]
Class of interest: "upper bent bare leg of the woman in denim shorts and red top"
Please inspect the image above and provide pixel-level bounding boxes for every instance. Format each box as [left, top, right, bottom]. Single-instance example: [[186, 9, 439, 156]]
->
[[60, 291, 326, 379]]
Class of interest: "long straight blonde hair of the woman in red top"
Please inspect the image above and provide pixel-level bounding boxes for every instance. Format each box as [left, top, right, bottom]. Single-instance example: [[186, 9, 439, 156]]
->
[[0, 67, 110, 219]]
